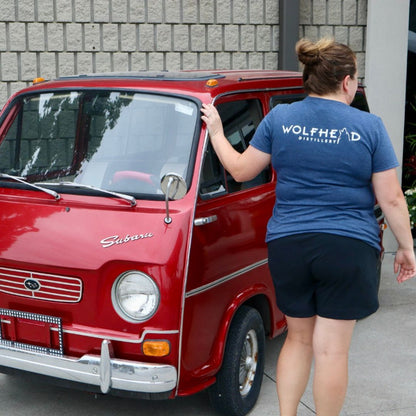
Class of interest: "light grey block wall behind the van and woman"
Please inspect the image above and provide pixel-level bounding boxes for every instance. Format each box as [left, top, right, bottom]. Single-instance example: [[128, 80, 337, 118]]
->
[[0, 0, 367, 106]]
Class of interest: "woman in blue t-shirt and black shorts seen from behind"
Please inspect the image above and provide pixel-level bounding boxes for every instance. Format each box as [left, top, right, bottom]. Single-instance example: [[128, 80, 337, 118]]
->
[[201, 39, 416, 416]]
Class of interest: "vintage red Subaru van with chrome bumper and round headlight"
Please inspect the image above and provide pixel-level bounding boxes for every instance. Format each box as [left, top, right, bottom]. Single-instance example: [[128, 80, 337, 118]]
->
[[0, 71, 382, 415]]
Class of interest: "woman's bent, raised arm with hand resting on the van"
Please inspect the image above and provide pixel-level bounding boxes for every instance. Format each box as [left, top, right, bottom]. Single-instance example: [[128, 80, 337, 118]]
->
[[201, 104, 271, 182]]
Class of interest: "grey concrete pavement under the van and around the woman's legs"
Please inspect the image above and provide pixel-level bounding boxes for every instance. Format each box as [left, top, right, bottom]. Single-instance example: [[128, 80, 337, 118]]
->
[[0, 253, 416, 416]]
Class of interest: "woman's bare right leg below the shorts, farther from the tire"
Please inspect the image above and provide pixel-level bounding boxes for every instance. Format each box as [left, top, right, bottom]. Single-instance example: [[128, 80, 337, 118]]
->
[[313, 316, 355, 416]]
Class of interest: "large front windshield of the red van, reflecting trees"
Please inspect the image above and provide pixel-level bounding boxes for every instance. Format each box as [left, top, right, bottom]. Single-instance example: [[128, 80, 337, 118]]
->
[[0, 90, 198, 195]]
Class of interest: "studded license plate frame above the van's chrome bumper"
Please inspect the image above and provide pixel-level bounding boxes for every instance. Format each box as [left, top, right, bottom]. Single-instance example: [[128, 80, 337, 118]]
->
[[0, 308, 64, 356]]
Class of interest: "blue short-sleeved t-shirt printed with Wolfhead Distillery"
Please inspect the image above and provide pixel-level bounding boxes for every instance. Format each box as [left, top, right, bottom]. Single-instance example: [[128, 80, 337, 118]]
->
[[250, 97, 398, 249]]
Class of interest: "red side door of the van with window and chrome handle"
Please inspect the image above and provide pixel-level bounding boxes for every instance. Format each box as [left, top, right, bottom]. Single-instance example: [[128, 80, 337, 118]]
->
[[182, 94, 283, 394]]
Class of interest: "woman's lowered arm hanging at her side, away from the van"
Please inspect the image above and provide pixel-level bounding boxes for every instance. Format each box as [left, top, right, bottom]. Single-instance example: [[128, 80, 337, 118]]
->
[[372, 169, 416, 282]]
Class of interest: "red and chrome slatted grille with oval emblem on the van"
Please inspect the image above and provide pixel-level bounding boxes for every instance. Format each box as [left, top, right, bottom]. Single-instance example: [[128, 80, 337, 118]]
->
[[0, 267, 82, 303]]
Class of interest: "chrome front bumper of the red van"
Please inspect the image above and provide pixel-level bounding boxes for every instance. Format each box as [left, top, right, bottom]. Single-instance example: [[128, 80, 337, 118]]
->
[[0, 340, 177, 393]]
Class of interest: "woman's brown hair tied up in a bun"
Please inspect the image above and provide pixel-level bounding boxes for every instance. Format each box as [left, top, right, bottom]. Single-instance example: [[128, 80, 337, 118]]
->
[[296, 38, 357, 95]]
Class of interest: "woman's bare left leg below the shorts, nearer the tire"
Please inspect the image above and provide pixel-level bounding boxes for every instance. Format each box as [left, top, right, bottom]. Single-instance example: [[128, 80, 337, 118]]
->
[[276, 317, 316, 416]]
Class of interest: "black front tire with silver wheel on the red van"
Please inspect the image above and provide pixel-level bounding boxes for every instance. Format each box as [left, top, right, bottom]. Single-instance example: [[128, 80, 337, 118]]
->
[[209, 306, 265, 416]]
